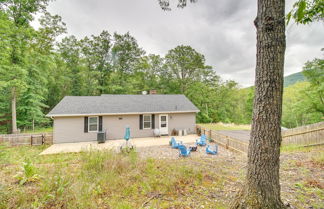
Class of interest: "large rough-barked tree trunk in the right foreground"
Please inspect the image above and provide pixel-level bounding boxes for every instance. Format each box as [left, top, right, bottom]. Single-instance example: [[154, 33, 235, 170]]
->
[[232, 0, 286, 209]]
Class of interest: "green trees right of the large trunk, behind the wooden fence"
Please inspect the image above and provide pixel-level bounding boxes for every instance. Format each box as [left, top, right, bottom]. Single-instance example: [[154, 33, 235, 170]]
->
[[282, 56, 324, 128]]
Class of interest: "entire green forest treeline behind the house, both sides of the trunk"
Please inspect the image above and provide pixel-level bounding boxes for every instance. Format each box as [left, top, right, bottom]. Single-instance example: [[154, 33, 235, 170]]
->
[[0, 0, 324, 132]]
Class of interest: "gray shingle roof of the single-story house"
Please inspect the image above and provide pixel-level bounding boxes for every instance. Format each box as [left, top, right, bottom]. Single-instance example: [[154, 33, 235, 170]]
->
[[47, 94, 199, 116]]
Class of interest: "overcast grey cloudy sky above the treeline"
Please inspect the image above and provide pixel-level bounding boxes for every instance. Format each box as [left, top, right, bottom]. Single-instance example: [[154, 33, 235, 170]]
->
[[48, 0, 324, 86]]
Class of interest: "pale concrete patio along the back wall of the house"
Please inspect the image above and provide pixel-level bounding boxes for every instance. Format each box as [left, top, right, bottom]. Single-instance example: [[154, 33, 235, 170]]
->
[[40, 135, 199, 155]]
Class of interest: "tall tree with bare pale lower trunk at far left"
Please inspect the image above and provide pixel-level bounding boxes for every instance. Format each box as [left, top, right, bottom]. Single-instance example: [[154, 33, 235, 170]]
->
[[0, 0, 48, 133]]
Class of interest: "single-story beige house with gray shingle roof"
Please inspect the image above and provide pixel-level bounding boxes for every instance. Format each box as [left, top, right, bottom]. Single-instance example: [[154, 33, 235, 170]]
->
[[47, 94, 199, 143]]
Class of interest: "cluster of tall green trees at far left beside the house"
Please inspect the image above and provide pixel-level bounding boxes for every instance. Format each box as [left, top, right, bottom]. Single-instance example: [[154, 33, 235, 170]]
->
[[0, 0, 61, 131]]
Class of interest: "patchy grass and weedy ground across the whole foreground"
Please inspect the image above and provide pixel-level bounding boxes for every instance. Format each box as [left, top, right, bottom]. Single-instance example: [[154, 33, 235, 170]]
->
[[0, 144, 324, 209]]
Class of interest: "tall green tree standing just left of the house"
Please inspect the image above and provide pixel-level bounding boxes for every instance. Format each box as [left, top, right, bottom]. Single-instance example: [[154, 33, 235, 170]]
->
[[17, 13, 65, 130]]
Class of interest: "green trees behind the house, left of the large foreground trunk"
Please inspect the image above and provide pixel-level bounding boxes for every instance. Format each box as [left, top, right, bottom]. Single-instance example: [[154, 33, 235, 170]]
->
[[0, 2, 256, 131]]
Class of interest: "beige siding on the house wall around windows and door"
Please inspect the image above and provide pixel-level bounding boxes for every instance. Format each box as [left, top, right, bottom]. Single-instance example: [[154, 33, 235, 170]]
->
[[53, 113, 196, 143]]
